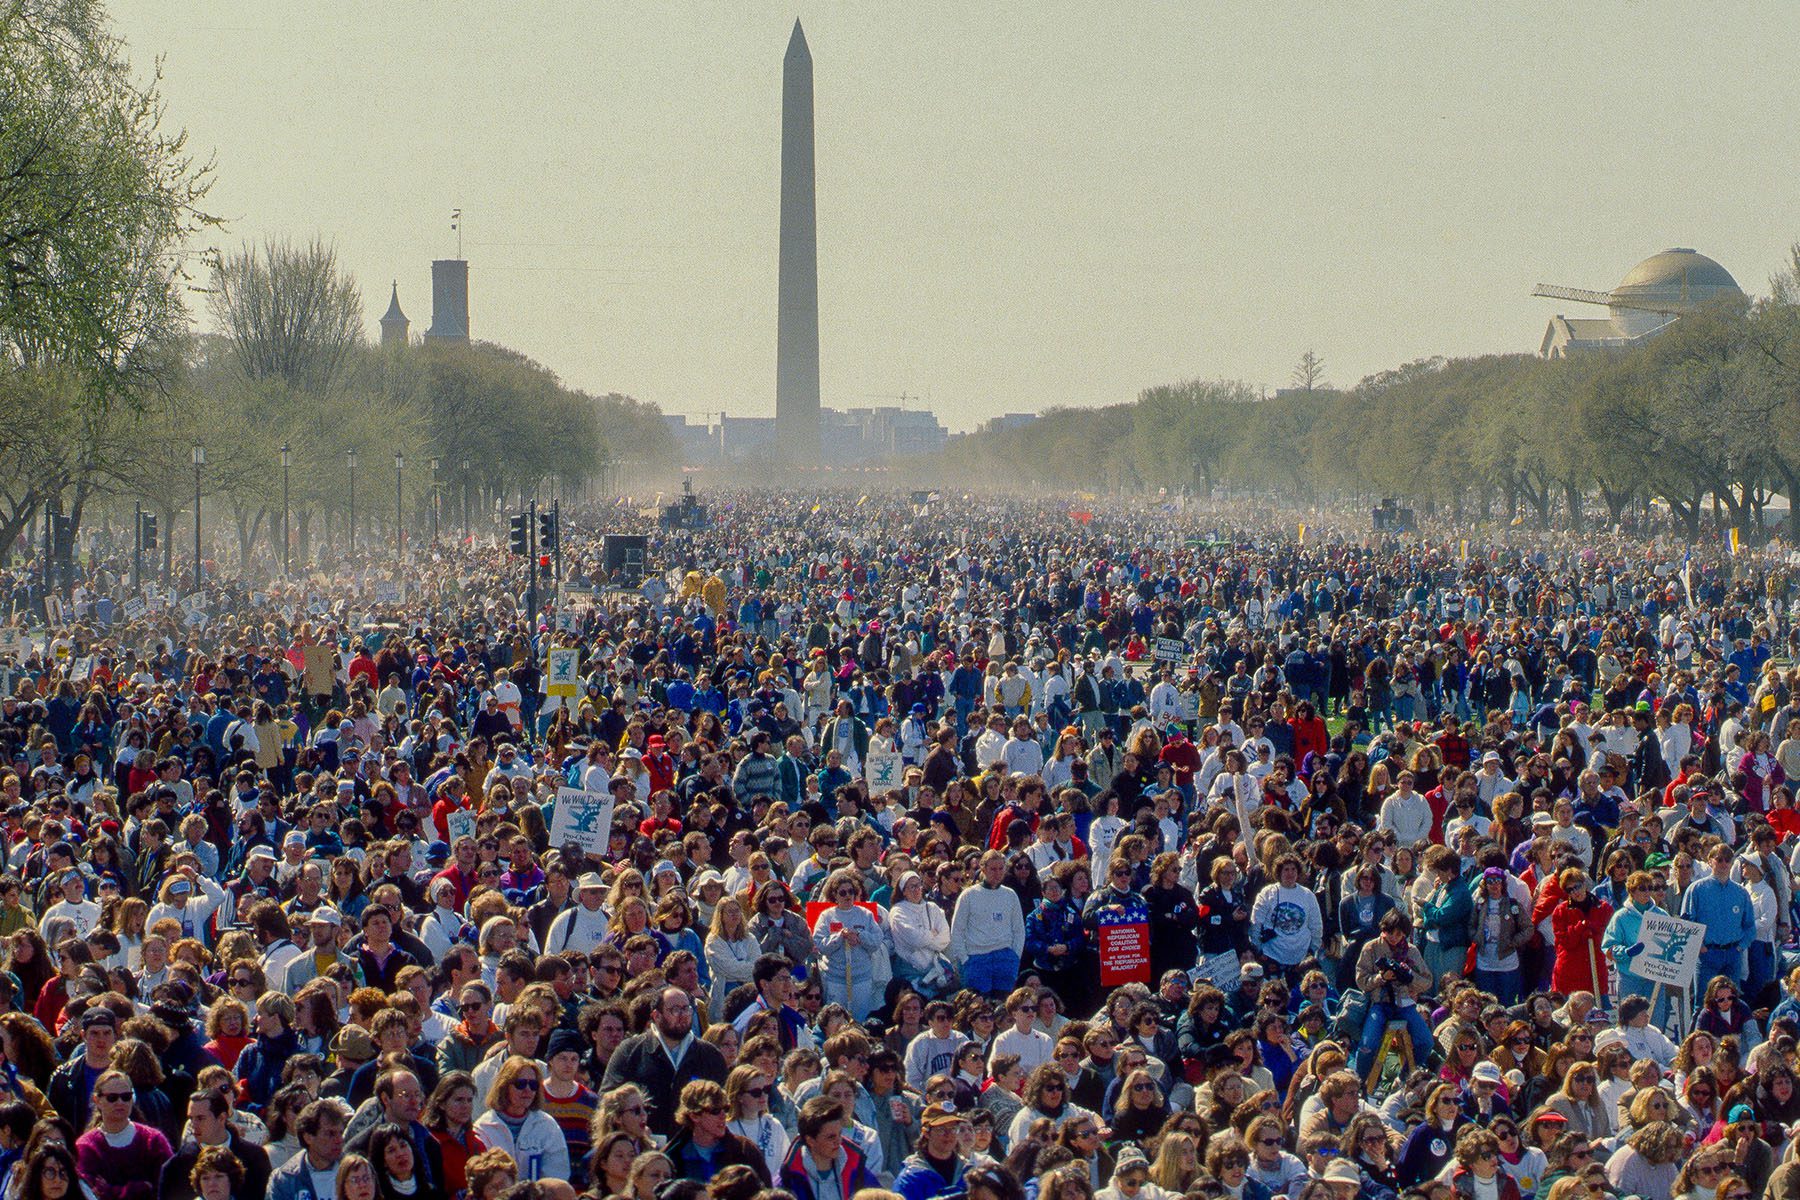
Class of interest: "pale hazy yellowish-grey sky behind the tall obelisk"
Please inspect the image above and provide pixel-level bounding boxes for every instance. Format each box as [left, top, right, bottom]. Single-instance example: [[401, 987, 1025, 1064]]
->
[[113, 0, 1800, 428]]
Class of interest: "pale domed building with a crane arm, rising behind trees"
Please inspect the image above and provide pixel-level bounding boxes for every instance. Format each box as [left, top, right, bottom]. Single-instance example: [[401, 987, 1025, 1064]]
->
[[1532, 246, 1744, 358]]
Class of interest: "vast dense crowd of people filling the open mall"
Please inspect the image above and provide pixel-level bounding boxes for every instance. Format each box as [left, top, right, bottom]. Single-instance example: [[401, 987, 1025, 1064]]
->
[[0, 491, 1800, 1200]]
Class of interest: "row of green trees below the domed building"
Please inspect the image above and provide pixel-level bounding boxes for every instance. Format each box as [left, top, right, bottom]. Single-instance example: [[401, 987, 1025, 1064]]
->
[[940, 245, 1800, 542]]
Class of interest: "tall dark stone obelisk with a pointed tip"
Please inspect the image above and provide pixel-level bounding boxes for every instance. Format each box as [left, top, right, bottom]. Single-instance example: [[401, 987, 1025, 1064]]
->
[[776, 22, 819, 464]]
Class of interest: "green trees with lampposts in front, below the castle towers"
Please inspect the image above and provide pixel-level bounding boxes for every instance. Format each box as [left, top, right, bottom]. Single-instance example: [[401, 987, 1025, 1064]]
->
[[0, 0, 677, 565]]
